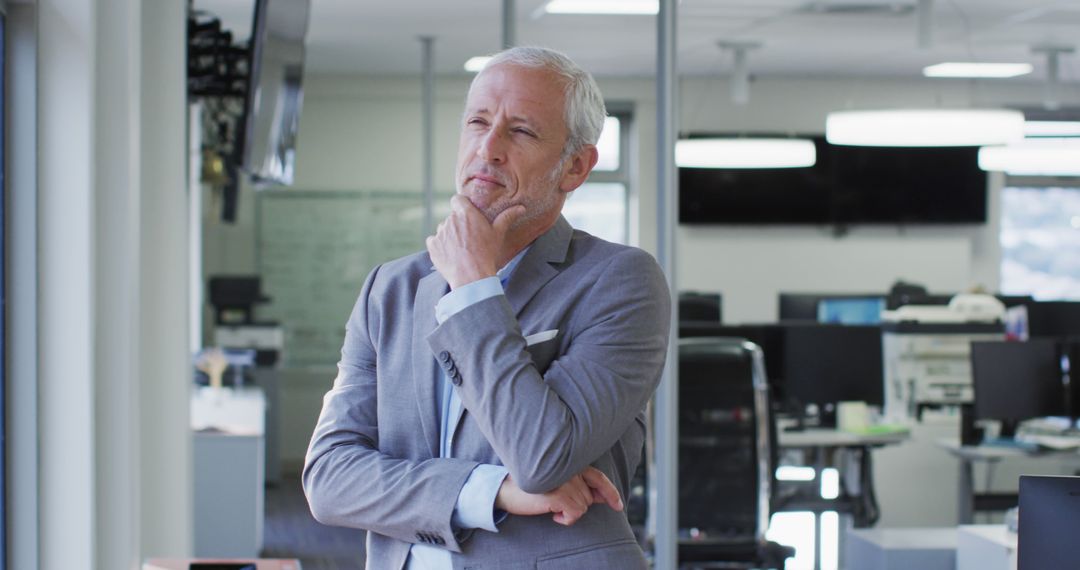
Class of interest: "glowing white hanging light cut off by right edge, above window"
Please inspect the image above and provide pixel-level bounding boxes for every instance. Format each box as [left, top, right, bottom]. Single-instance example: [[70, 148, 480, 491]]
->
[[978, 138, 1080, 176]]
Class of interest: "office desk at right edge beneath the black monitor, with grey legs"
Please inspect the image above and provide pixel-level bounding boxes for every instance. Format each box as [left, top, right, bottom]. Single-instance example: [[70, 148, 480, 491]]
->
[[937, 437, 1080, 525]]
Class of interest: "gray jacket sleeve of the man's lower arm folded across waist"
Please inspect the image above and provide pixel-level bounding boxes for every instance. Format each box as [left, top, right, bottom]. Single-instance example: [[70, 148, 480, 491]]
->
[[302, 268, 477, 552]]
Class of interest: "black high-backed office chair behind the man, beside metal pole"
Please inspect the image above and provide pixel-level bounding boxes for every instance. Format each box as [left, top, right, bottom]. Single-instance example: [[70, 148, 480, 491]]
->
[[678, 337, 795, 568]]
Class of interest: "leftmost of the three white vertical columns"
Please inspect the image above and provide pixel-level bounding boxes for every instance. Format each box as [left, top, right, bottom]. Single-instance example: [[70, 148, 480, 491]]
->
[[36, 0, 96, 570]]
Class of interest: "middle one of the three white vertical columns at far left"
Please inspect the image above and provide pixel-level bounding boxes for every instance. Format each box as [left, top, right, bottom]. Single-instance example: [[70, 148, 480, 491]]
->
[[90, 0, 141, 569]]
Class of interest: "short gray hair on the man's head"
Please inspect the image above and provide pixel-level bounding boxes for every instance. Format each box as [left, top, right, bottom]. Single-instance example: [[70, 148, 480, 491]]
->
[[469, 45, 607, 157]]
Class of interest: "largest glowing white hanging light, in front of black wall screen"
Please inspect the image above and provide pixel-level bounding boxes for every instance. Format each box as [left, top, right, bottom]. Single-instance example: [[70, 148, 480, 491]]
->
[[825, 109, 1024, 147]]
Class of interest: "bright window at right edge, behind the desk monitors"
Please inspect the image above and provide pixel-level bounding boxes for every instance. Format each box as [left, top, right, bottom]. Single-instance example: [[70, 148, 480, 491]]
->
[[1001, 187, 1080, 300]]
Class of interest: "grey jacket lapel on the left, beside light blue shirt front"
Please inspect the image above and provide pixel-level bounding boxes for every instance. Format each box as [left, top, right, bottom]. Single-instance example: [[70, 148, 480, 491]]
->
[[413, 263, 447, 458]]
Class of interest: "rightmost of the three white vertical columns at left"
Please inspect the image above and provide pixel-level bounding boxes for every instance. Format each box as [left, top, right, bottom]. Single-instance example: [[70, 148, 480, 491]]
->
[[138, 0, 193, 556]]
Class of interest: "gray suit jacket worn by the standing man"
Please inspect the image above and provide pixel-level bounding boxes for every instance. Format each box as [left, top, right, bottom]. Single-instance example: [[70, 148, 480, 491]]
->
[[303, 218, 671, 570]]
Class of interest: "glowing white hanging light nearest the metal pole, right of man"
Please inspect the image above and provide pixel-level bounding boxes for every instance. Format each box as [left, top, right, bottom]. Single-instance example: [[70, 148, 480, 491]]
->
[[675, 138, 818, 168]]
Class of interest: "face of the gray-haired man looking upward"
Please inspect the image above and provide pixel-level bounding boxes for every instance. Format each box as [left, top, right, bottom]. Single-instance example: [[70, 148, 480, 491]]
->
[[457, 64, 574, 228]]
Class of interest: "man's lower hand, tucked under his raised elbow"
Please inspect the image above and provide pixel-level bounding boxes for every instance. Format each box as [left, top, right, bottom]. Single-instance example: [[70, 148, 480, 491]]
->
[[495, 466, 622, 527]]
